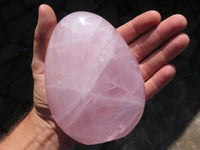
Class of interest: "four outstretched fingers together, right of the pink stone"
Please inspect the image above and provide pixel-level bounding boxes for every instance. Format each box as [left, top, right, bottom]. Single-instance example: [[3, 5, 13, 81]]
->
[[117, 11, 189, 100]]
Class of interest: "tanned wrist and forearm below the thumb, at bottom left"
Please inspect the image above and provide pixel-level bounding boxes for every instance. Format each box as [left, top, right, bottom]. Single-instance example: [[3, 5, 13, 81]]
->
[[0, 108, 75, 150]]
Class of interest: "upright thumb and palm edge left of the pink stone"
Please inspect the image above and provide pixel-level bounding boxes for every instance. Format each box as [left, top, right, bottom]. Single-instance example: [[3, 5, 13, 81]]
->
[[32, 5, 76, 149]]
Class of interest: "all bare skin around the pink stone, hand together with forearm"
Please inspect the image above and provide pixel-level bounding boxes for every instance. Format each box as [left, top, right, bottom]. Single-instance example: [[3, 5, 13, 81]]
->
[[0, 5, 189, 150]]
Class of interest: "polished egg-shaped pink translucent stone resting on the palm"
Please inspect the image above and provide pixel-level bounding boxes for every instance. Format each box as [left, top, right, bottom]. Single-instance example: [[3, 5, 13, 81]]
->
[[45, 12, 145, 144]]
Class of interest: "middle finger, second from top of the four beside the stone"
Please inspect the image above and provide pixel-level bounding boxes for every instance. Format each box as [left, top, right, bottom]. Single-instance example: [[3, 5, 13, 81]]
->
[[129, 15, 187, 62]]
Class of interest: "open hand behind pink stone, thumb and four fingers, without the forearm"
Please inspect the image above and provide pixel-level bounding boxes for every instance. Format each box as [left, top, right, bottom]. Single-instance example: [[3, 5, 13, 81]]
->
[[32, 5, 189, 148]]
